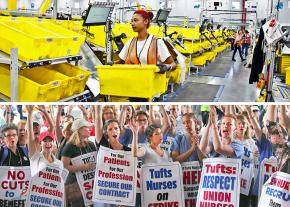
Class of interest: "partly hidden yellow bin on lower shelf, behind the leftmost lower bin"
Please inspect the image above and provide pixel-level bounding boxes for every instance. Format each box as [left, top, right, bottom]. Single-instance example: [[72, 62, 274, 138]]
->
[[47, 63, 92, 95]]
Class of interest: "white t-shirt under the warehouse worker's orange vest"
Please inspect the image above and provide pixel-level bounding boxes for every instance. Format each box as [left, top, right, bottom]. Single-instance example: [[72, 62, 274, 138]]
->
[[119, 35, 171, 65]]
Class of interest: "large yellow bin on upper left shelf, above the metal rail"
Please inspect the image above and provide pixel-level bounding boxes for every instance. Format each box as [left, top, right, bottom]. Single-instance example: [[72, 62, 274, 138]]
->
[[0, 21, 62, 61]]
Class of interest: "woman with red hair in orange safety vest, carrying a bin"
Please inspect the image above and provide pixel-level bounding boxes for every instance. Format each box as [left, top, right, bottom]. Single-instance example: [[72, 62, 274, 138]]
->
[[116, 10, 176, 71]]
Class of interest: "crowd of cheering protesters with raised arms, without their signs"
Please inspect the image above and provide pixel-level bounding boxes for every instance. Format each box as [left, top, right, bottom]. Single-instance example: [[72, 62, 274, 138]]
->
[[0, 105, 290, 207]]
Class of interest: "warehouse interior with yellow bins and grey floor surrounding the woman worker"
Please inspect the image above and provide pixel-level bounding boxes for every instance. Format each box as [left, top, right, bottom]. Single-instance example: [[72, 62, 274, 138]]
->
[[0, 0, 290, 102]]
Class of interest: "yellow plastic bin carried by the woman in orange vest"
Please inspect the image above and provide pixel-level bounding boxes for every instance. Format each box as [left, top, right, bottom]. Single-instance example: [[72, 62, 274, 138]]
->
[[96, 65, 167, 100]]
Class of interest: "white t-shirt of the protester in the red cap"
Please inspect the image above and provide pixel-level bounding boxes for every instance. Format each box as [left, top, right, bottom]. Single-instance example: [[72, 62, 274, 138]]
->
[[30, 152, 63, 177]]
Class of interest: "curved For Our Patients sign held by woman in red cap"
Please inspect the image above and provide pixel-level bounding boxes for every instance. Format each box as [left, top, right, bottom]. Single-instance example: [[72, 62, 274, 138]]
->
[[26, 165, 68, 207]]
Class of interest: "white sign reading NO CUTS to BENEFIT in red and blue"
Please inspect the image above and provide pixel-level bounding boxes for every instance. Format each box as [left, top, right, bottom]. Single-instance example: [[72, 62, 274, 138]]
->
[[0, 166, 31, 207]]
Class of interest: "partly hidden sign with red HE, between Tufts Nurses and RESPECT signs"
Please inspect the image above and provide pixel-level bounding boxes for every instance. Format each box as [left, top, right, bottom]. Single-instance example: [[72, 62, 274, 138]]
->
[[181, 161, 201, 207]]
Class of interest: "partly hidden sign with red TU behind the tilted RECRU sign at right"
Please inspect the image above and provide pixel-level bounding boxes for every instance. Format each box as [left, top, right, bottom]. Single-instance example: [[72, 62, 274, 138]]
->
[[258, 156, 278, 200]]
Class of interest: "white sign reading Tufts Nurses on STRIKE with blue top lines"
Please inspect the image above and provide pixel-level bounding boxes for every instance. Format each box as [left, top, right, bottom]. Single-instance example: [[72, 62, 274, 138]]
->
[[141, 162, 184, 207]]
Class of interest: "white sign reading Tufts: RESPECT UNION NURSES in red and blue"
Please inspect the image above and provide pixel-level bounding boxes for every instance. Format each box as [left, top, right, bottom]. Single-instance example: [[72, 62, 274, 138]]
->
[[197, 158, 241, 207]]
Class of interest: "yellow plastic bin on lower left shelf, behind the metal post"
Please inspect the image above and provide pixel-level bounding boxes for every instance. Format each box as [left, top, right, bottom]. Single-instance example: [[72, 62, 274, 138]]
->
[[0, 64, 68, 102]]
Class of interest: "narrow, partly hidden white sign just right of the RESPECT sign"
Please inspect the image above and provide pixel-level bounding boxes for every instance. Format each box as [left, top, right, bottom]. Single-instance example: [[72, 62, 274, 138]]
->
[[241, 146, 254, 195]]
